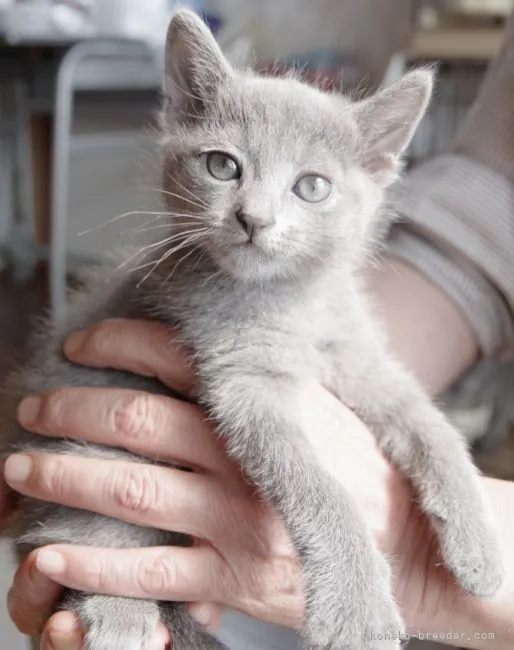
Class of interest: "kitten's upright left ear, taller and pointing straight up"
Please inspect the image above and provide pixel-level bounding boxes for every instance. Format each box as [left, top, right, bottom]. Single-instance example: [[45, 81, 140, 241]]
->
[[164, 9, 232, 120]]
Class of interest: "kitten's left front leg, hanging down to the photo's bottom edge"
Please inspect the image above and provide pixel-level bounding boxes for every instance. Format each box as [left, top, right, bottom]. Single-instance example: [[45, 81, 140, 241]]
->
[[202, 369, 403, 650]]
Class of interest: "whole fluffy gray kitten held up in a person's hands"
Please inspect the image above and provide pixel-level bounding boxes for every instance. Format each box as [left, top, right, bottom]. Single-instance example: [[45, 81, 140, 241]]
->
[[0, 10, 503, 650]]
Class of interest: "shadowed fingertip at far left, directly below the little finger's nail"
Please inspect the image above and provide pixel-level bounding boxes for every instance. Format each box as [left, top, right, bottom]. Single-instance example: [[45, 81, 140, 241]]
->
[[7, 553, 62, 636]]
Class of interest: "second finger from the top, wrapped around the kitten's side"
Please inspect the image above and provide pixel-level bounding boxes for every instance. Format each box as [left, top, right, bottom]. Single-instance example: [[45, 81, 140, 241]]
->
[[18, 388, 224, 470]]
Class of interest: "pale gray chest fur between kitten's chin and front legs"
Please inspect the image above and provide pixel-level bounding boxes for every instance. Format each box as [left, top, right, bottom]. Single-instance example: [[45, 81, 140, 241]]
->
[[152, 260, 359, 385]]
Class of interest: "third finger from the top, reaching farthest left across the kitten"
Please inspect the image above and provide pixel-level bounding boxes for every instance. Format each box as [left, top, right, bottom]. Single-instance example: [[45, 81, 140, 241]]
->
[[4, 453, 225, 540]]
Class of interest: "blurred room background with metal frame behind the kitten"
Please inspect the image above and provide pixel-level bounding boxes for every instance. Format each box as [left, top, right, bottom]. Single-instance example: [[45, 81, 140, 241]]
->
[[0, 0, 514, 650]]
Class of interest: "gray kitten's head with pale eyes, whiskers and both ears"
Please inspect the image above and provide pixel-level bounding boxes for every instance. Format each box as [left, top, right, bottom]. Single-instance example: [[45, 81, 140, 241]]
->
[[158, 10, 432, 281]]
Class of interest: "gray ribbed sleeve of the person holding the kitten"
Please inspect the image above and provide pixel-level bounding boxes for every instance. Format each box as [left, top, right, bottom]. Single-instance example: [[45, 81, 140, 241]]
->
[[389, 14, 514, 355]]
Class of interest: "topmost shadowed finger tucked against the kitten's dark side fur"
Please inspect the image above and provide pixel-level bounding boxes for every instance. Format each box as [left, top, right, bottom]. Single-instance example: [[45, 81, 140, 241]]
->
[[64, 319, 195, 395]]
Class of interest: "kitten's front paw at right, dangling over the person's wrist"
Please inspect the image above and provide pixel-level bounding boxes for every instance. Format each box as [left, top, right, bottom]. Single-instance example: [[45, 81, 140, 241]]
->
[[438, 514, 505, 597]]
